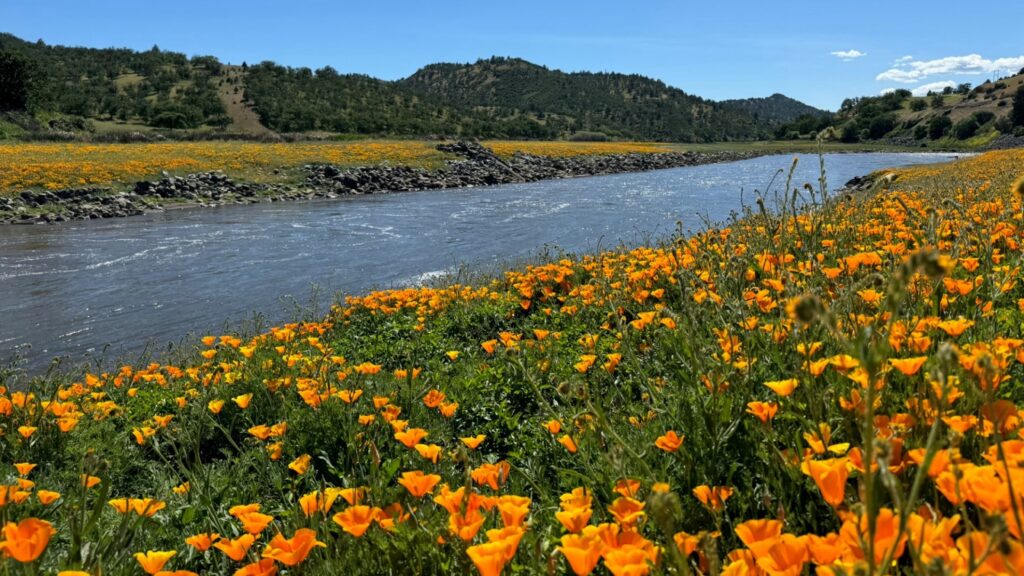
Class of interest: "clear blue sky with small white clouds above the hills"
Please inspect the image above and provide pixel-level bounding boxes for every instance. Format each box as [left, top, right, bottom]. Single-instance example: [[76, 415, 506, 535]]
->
[[0, 0, 1024, 110]]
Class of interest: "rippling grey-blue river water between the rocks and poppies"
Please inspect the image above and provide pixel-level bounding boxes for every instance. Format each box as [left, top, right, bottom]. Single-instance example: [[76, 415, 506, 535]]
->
[[0, 154, 952, 371]]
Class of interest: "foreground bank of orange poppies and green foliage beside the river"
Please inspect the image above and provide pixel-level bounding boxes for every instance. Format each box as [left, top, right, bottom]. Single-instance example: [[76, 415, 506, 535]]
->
[[6, 151, 1024, 576]]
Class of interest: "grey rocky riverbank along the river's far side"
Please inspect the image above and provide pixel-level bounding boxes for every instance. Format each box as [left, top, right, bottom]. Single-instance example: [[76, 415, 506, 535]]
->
[[0, 141, 757, 223]]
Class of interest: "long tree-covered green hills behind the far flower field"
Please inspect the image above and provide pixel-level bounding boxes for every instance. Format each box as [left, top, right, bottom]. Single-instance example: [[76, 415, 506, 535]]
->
[[0, 34, 820, 141]]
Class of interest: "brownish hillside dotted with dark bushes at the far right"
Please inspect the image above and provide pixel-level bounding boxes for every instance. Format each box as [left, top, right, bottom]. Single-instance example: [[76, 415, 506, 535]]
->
[[775, 70, 1024, 147]]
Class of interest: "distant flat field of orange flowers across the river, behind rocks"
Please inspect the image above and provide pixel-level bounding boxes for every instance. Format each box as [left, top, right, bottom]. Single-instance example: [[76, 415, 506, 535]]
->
[[0, 140, 666, 195]]
